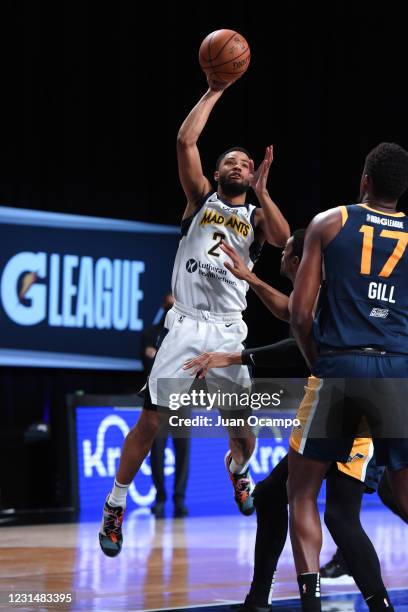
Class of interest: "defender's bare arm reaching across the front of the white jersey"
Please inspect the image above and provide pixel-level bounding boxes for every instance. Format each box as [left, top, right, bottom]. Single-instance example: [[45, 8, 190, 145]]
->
[[221, 242, 290, 321]]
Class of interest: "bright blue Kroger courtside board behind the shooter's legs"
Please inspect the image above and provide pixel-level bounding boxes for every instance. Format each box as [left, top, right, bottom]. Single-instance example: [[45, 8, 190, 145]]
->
[[75, 406, 288, 516]]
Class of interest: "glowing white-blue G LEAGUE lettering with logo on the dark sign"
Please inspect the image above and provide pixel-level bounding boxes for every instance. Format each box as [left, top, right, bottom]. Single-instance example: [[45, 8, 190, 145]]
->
[[0, 251, 145, 331]]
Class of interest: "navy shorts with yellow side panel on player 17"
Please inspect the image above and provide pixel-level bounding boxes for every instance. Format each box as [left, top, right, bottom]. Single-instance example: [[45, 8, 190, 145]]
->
[[290, 352, 408, 468]]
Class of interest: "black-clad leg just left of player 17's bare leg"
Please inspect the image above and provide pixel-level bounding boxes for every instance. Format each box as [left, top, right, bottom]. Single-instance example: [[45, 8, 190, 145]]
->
[[243, 455, 288, 612]]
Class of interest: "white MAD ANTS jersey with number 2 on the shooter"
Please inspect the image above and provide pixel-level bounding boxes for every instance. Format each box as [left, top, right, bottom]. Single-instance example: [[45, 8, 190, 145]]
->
[[172, 193, 260, 313]]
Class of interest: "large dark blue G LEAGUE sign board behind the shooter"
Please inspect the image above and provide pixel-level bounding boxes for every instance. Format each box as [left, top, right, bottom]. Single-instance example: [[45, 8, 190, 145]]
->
[[0, 207, 179, 369]]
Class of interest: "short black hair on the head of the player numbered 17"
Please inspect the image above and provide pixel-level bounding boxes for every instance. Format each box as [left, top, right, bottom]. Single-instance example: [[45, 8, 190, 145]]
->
[[364, 142, 408, 200]]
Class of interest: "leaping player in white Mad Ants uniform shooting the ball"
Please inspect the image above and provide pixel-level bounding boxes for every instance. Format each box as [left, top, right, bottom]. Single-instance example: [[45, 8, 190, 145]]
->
[[99, 64, 290, 557]]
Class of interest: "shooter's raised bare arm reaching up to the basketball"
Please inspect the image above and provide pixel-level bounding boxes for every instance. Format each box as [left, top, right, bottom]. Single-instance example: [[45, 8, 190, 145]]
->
[[177, 83, 223, 219]]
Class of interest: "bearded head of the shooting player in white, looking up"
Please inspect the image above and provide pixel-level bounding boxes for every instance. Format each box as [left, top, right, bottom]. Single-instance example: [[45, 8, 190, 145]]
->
[[214, 147, 251, 196]]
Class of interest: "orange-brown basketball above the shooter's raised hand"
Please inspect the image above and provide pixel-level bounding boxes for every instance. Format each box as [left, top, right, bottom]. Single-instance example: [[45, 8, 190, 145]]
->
[[198, 30, 251, 83]]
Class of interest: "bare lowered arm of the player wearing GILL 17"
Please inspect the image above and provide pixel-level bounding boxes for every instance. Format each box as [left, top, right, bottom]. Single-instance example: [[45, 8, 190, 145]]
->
[[290, 208, 342, 368]]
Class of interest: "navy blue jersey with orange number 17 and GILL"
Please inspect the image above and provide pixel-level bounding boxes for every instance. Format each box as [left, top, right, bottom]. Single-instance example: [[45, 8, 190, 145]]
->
[[314, 204, 408, 354]]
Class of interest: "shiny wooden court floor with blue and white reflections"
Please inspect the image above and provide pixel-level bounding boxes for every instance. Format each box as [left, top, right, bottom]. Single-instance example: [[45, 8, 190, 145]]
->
[[0, 510, 408, 612]]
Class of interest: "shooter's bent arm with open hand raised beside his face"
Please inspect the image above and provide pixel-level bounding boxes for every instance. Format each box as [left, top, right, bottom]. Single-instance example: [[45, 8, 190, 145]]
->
[[250, 145, 290, 247]]
